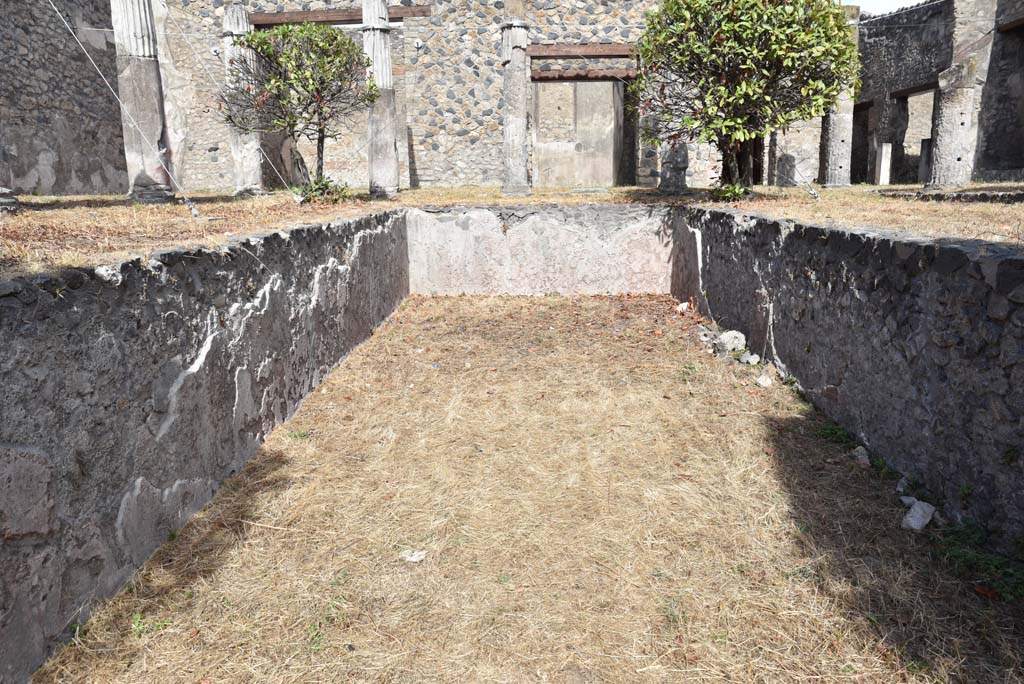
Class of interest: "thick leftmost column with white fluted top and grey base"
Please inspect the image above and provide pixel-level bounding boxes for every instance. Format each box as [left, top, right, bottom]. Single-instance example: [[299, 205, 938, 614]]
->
[[111, 0, 174, 203]]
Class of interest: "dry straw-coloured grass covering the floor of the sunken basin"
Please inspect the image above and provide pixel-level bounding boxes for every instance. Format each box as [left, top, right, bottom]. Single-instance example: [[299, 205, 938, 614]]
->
[[37, 298, 1024, 684]]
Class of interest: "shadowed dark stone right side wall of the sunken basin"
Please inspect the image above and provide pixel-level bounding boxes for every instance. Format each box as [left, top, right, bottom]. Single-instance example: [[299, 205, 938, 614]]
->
[[672, 208, 1024, 553]]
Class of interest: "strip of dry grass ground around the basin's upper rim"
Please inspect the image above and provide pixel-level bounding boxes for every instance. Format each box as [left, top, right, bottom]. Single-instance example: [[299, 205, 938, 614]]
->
[[0, 186, 1024, 276]]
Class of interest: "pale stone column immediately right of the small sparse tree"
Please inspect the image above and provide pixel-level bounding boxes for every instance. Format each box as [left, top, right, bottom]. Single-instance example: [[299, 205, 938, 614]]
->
[[362, 0, 399, 197]]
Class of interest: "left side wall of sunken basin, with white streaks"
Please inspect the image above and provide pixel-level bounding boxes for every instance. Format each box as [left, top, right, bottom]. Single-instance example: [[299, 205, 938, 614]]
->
[[0, 214, 409, 684]]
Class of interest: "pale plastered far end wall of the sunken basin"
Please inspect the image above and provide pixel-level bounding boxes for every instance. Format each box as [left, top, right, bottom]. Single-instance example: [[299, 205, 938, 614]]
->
[[408, 205, 672, 295]]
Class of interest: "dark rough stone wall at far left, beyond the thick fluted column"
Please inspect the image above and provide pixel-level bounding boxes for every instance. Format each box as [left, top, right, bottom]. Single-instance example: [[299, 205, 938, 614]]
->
[[0, 0, 128, 195]]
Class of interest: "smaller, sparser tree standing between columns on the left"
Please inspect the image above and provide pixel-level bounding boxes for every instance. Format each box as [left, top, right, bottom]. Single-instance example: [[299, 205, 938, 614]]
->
[[220, 24, 378, 184]]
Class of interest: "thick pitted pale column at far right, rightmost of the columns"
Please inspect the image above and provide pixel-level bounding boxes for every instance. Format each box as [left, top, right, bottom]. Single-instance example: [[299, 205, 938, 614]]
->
[[928, 0, 996, 187]]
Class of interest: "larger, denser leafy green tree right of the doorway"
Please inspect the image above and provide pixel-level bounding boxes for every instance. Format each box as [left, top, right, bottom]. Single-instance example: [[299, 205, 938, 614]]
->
[[633, 0, 859, 191]]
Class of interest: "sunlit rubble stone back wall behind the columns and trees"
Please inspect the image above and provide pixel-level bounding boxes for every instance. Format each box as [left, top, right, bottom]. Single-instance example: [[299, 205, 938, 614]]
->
[[158, 0, 733, 189]]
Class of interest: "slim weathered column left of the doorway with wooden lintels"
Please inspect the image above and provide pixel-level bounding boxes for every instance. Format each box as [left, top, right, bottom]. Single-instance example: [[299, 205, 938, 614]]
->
[[501, 20, 530, 195]]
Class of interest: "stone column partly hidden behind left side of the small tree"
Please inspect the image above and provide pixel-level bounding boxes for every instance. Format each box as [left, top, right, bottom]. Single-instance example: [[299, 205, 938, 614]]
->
[[223, 0, 266, 197]]
